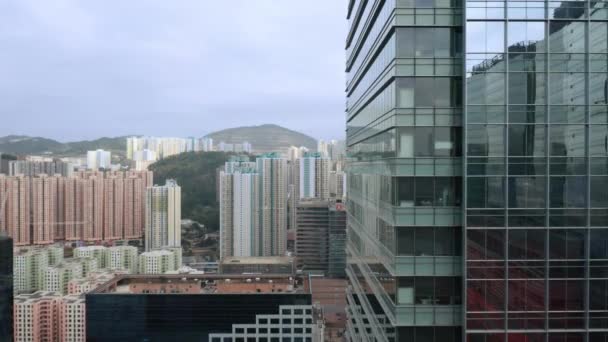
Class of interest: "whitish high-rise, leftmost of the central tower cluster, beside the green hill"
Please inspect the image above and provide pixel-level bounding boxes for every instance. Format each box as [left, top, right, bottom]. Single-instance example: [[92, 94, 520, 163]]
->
[[220, 157, 259, 258]]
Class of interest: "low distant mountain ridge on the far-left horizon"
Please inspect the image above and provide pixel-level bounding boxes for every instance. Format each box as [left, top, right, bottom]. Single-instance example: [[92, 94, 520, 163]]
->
[[0, 135, 127, 156]]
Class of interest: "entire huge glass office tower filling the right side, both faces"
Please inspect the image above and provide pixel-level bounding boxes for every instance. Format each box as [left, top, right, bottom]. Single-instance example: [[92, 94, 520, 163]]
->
[[346, 0, 608, 342]]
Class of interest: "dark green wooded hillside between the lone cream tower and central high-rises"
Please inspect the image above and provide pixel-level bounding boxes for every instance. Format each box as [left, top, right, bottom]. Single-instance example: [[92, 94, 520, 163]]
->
[[150, 152, 232, 232]]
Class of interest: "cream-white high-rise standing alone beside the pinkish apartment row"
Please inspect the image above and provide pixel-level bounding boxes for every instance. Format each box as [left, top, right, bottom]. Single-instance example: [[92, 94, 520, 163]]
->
[[145, 179, 182, 251]]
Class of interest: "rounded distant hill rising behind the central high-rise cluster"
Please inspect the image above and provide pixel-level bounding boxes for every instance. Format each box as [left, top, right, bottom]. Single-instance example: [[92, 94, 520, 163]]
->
[[205, 124, 317, 153]]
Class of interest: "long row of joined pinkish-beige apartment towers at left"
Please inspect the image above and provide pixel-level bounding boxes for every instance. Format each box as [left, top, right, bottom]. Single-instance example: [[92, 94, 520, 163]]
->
[[0, 171, 153, 246]]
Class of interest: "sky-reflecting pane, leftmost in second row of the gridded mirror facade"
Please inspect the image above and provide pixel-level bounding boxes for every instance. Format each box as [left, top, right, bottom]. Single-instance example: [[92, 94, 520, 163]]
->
[[466, 21, 505, 53]]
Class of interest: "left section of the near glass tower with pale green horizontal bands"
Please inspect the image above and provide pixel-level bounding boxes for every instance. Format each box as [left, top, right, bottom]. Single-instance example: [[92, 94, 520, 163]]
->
[[346, 0, 464, 342]]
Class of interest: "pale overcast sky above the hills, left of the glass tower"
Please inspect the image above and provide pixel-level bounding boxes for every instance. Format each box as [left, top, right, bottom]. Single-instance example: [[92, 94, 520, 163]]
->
[[0, 0, 346, 141]]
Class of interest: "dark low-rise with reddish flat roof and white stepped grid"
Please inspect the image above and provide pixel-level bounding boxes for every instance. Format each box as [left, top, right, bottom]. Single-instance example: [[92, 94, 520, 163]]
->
[[85, 274, 323, 342]]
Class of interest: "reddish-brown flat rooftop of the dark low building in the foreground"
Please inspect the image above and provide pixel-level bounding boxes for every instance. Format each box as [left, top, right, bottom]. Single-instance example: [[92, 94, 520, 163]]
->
[[89, 274, 310, 295]]
